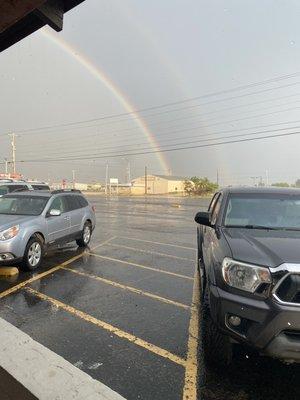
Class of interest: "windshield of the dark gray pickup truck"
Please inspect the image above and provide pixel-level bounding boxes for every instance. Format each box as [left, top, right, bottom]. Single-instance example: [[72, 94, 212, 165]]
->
[[224, 194, 300, 230]]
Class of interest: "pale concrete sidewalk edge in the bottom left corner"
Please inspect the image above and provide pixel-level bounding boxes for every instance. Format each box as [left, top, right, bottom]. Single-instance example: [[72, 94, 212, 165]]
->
[[0, 319, 124, 400]]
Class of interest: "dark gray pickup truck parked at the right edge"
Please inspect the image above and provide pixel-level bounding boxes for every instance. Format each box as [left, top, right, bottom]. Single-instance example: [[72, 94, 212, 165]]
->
[[195, 188, 300, 365]]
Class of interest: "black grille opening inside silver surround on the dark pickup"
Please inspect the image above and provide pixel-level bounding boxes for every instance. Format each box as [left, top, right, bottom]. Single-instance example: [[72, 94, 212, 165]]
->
[[275, 273, 300, 305]]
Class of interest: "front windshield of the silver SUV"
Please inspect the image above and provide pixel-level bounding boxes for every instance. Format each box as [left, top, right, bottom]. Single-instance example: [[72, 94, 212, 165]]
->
[[0, 196, 48, 215]]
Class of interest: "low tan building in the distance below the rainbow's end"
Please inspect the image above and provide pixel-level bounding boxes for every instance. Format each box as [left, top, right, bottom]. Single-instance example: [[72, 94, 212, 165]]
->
[[132, 175, 186, 194]]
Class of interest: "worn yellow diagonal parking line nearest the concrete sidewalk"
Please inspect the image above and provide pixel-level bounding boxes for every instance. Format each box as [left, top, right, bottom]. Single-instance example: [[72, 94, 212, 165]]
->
[[26, 287, 186, 367]]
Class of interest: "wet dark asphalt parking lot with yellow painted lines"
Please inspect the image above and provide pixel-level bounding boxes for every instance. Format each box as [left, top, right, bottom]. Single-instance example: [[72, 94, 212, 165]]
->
[[0, 196, 300, 400]]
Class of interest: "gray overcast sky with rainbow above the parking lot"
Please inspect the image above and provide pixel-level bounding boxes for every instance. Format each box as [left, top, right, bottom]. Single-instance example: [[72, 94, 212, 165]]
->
[[0, 0, 300, 185]]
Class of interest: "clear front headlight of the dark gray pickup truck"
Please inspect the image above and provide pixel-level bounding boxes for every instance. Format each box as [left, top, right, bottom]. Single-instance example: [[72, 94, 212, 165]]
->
[[222, 257, 272, 293]]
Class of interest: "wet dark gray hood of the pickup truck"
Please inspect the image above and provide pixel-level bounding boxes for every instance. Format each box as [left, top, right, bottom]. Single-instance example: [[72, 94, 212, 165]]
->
[[222, 228, 300, 268]]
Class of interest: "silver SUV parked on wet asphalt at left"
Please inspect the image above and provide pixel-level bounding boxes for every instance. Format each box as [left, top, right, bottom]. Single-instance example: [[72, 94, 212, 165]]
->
[[0, 190, 96, 270]]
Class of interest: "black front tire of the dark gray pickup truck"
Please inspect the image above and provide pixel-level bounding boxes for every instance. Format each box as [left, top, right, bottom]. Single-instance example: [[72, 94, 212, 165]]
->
[[200, 285, 232, 368]]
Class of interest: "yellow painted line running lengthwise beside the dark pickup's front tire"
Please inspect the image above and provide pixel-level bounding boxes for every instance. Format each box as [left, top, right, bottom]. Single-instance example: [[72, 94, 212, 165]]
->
[[182, 267, 200, 400]]
